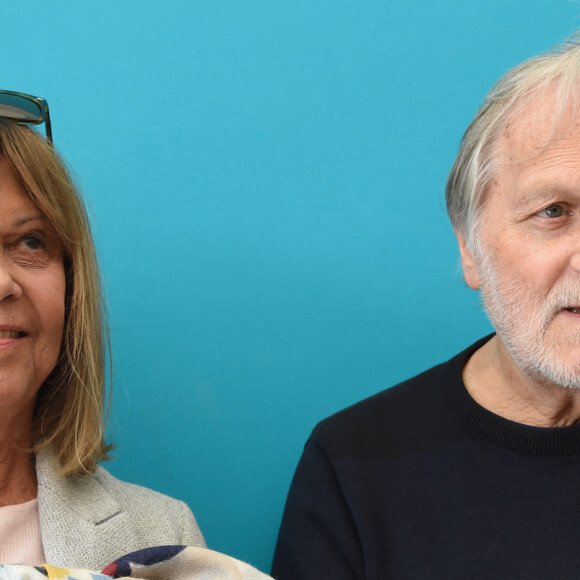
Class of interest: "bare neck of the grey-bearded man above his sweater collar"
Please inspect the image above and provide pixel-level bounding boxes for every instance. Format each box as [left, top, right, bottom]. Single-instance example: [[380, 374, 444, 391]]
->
[[463, 335, 580, 427]]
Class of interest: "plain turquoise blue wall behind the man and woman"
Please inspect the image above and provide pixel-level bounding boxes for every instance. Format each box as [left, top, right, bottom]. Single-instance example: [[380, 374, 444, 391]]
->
[[0, 0, 580, 570]]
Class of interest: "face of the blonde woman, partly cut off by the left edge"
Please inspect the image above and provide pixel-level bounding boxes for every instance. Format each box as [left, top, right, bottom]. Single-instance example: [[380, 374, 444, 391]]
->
[[0, 157, 65, 428]]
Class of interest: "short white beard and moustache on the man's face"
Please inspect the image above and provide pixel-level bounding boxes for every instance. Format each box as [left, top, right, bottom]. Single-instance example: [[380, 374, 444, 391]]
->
[[475, 245, 580, 389]]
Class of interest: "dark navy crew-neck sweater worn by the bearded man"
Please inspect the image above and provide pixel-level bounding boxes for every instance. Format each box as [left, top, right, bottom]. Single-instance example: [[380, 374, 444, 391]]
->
[[272, 337, 580, 580]]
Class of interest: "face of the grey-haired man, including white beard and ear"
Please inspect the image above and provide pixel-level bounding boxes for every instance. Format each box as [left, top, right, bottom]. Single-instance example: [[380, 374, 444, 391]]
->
[[458, 96, 580, 387]]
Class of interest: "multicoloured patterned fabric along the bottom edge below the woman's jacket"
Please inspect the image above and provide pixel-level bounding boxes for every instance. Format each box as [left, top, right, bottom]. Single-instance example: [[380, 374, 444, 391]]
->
[[0, 546, 270, 580]]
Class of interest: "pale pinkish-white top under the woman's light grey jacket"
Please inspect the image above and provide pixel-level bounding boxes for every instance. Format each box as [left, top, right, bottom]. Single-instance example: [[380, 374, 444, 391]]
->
[[0, 498, 45, 566]]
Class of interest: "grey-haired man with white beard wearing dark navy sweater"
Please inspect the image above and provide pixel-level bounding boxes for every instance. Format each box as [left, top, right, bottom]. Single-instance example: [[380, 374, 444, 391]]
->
[[272, 39, 580, 580]]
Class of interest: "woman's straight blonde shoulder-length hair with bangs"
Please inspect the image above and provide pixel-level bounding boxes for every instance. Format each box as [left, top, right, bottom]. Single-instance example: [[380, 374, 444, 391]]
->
[[0, 120, 109, 474]]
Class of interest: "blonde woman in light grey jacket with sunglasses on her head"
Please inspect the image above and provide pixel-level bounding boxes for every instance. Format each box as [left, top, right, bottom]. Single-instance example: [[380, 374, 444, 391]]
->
[[0, 91, 204, 570]]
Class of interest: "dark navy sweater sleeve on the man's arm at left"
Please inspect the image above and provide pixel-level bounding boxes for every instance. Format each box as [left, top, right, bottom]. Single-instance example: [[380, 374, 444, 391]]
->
[[272, 435, 365, 580]]
